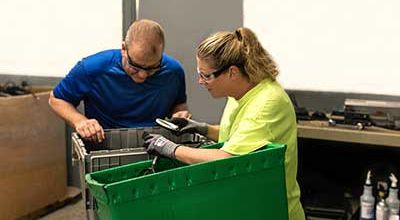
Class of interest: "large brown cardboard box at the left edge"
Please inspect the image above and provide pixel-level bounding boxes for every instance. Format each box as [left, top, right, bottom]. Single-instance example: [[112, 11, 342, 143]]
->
[[0, 87, 67, 219]]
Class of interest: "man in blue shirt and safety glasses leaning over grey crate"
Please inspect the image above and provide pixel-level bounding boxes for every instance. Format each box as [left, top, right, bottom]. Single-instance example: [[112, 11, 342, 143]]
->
[[49, 19, 190, 142]]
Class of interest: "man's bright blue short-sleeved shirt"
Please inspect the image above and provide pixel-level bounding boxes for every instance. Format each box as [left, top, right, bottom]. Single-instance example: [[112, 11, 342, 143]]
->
[[53, 50, 186, 128]]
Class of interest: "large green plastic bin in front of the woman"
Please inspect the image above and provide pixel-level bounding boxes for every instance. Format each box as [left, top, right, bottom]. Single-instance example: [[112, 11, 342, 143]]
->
[[86, 143, 288, 220]]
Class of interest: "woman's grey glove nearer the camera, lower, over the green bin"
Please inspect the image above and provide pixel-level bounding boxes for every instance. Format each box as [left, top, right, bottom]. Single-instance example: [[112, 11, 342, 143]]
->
[[142, 132, 179, 159]]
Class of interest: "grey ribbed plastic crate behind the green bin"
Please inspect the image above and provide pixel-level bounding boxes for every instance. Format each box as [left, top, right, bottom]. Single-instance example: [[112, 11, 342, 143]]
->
[[72, 127, 208, 219]]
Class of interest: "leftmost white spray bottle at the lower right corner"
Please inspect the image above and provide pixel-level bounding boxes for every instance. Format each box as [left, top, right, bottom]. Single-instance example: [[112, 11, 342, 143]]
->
[[360, 171, 375, 220]]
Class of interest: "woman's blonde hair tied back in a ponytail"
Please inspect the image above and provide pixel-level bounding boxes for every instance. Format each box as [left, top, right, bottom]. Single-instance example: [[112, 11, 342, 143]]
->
[[197, 27, 279, 83]]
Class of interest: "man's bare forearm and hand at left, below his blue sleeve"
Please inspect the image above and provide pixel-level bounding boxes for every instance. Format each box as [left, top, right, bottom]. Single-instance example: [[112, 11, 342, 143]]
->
[[49, 92, 105, 142]]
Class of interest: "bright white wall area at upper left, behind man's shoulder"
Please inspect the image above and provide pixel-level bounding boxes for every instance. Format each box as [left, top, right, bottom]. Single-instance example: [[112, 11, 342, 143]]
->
[[0, 0, 122, 77]]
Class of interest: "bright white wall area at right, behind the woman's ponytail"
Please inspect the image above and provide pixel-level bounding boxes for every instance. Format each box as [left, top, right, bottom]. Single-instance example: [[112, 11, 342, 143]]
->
[[243, 0, 400, 95]]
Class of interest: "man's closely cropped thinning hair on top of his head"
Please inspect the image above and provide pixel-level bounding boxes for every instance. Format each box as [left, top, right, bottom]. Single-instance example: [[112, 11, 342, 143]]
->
[[125, 19, 165, 49]]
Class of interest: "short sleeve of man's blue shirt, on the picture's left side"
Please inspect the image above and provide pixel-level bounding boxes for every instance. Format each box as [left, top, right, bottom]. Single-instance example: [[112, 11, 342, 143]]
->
[[53, 61, 91, 107]]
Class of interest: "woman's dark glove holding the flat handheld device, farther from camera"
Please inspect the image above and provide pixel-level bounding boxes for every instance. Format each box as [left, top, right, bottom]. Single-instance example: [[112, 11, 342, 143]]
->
[[168, 118, 208, 136]]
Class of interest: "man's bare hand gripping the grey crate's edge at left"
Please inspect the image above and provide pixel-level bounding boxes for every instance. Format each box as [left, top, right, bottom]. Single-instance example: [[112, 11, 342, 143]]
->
[[74, 119, 105, 143]]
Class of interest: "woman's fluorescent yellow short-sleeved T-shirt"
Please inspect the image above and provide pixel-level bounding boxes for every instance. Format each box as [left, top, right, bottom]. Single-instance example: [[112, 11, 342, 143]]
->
[[219, 79, 305, 220]]
